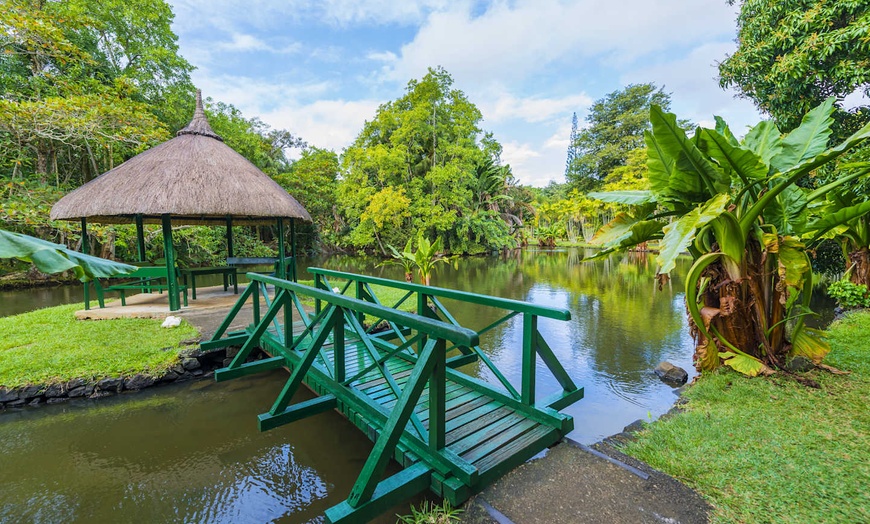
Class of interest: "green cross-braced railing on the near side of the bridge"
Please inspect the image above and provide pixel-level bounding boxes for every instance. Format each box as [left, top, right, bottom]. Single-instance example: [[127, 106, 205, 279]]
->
[[201, 273, 490, 522]]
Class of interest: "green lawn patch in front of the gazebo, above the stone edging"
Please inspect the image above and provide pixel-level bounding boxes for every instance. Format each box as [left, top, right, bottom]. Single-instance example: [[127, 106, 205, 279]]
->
[[0, 304, 198, 387]]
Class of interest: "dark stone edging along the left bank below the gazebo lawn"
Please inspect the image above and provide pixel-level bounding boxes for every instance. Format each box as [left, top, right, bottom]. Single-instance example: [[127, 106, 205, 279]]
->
[[0, 347, 255, 411]]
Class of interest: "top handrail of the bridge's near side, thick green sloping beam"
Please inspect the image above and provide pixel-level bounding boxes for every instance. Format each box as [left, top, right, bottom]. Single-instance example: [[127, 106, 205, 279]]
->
[[247, 273, 480, 346]]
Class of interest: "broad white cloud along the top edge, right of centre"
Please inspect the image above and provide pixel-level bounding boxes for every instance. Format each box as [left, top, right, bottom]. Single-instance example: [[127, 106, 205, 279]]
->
[[391, 0, 734, 83]]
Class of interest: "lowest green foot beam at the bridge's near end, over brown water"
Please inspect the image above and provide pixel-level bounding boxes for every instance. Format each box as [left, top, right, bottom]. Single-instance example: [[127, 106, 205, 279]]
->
[[326, 462, 432, 524]]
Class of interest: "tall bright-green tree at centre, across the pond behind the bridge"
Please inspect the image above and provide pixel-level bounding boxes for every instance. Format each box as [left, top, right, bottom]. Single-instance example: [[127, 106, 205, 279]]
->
[[338, 68, 513, 253]]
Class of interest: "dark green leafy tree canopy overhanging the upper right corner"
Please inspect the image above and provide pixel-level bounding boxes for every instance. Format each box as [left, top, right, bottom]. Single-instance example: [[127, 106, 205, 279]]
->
[[719, 0, 870, 135]]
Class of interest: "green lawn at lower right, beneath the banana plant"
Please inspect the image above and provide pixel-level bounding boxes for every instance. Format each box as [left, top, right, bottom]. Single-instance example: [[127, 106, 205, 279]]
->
[[624, 312, 870, 523]]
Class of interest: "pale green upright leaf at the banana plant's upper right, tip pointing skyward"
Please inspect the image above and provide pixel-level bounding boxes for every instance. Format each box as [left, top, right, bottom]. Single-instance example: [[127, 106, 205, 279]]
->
[[770, 97, 834, 171]]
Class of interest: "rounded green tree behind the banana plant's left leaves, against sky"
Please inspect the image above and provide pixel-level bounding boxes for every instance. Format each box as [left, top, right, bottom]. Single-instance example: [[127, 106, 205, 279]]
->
[[566, 83, 671, 192]]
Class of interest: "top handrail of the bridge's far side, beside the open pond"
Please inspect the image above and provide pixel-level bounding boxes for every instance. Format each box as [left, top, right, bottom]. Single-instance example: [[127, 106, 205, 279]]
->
[[308, 267, 571, 320]]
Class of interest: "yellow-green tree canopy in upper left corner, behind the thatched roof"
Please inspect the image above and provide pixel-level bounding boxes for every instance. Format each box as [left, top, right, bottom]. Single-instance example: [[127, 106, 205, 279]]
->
[[0, 0, 192, 185]]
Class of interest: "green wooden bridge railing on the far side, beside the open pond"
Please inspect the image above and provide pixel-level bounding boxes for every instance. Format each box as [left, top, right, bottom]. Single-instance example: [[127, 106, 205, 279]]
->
[[308, 268, 583, 410]]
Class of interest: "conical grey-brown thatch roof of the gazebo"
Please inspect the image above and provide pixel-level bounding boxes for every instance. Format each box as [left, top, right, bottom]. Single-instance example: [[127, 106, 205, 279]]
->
[[51, 90, 311, 225]]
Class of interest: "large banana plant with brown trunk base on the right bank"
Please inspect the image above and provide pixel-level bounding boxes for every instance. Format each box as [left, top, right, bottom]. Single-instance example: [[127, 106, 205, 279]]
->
[[590, 98, 870, 376]]
